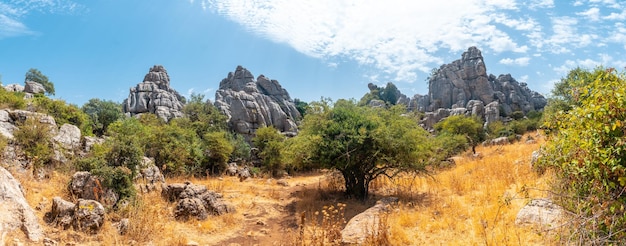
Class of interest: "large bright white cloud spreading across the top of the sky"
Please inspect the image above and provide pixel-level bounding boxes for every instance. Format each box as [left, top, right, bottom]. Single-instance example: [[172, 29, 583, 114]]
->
[[205, 0, 532, 82]]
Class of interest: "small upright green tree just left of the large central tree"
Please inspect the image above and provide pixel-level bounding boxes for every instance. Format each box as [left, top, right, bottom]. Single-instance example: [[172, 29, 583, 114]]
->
[[252, 126, 285, 176]]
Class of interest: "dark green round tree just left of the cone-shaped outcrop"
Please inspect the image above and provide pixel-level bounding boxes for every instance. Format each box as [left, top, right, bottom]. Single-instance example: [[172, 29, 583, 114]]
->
[[82, 98, 124, 136]]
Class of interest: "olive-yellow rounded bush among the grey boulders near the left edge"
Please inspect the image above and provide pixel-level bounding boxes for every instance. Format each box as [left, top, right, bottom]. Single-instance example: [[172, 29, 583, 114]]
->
[[13, 117, 54, 169]]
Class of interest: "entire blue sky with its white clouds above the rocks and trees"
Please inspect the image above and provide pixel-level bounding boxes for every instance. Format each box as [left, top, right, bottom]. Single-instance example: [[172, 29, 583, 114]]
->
[[0, 0, 626, 105]]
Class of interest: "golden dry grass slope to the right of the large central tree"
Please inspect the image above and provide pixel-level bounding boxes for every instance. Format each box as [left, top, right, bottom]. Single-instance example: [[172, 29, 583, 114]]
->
[[377, 134, 557, 245]]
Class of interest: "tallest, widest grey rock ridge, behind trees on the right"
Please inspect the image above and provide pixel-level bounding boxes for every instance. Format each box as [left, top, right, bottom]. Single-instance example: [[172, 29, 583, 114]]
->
[[398, 47, 547, 129]]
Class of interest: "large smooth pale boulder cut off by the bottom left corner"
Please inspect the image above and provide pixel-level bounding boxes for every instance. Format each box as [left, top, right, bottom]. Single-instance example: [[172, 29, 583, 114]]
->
[[0, 167, 44, 242]]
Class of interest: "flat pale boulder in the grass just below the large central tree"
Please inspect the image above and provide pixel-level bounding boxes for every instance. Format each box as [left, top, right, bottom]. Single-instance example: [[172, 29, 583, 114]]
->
[[341, 197, 398, 245]]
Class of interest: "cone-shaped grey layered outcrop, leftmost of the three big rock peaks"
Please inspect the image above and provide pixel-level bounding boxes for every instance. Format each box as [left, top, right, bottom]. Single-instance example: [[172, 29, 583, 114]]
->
[[123, 65, 185, 121]]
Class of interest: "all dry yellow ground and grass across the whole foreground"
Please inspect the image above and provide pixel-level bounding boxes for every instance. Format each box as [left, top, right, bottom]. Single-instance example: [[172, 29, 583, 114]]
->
[[9, 133, 557, 245]]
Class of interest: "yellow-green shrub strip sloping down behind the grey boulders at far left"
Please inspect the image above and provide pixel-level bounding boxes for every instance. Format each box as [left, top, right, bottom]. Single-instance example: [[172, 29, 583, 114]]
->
[[33, 95, 93, 136]]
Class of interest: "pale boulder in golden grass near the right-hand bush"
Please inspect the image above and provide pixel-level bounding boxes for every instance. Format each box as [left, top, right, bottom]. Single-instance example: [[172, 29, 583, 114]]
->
[[515, 198, 565, 229]]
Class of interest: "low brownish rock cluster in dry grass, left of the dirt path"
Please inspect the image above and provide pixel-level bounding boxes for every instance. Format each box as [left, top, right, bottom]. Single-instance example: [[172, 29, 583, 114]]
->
[[161, 182, 235, 220]]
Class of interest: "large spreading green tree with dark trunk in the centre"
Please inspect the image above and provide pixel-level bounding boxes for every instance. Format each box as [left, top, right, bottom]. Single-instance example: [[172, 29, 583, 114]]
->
[[290, 100, 432, 199]]
